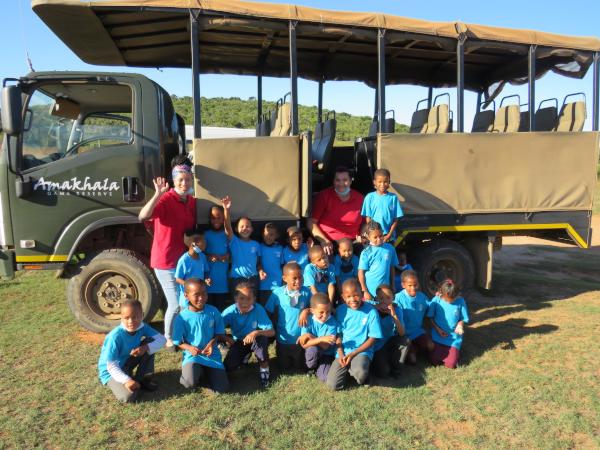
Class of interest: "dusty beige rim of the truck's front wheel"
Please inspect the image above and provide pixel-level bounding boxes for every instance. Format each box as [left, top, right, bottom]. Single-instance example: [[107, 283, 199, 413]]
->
[[84, 270, 138, 320]]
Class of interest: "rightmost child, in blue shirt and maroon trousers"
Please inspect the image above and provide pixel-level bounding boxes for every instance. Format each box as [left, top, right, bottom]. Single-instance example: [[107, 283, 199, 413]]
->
[[427, 279, 469, 369]]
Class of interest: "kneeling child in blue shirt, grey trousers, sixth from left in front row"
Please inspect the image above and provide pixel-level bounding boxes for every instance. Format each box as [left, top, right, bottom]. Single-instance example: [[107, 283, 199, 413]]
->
[[326, 278, 383, 390]]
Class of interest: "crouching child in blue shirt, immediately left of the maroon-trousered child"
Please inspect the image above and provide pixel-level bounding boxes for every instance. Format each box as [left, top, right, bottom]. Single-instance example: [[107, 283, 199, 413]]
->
[[394, 270, 433, 364]]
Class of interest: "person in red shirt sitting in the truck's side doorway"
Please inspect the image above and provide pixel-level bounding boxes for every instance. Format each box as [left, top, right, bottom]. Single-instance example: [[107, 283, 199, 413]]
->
[[307, 167, 364, 255]]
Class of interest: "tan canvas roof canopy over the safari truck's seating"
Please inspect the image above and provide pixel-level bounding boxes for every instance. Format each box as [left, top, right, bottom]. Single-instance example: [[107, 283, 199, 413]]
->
[[32, 0, 600, 96]]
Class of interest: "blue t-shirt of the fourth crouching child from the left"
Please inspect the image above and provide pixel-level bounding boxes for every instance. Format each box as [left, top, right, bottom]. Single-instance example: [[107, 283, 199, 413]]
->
[[265, 286, 311, 344]]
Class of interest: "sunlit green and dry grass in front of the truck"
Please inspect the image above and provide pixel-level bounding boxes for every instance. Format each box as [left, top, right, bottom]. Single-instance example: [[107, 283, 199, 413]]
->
[[0, 244, 600, 449]]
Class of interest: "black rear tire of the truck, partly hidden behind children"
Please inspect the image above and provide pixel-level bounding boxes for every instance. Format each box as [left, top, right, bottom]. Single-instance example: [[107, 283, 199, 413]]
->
[[415, 239, 475, 298]]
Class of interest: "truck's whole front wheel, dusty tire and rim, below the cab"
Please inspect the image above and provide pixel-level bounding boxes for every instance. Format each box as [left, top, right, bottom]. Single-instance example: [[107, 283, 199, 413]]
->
[[67, 249, 162, 333]]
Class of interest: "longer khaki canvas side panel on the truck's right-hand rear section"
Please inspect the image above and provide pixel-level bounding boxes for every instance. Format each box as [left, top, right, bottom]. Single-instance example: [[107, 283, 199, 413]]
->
[[377, 132, 599, 214]]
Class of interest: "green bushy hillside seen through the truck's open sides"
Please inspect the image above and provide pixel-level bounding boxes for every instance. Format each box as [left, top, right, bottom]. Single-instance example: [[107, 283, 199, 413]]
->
[[172, 95, 408, 141]]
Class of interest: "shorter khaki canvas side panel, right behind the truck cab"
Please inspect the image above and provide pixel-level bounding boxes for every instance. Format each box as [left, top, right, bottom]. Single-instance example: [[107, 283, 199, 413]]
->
[[194, 136, 301, 223]]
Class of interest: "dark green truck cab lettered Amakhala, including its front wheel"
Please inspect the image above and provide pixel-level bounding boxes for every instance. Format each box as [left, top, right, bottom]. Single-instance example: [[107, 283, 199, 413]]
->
[[0, 72, 185, 331]]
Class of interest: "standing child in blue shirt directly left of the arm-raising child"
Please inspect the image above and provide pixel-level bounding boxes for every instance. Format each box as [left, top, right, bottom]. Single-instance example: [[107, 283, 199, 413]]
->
[[204, 205, 231, 311]]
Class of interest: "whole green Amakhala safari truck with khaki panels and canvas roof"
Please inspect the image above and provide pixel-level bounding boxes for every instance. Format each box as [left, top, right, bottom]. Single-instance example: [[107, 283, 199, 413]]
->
[[0, 0, 600, 331]]
